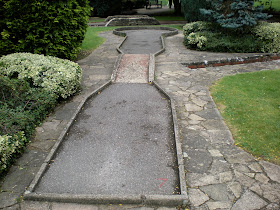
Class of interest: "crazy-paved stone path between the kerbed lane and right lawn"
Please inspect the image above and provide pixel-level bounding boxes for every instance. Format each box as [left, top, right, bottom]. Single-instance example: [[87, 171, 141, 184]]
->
[[156, 30, 280, 209]]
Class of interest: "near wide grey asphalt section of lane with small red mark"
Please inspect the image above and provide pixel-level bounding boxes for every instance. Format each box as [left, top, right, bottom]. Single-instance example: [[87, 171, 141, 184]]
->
[[35, 83, 178, 195]]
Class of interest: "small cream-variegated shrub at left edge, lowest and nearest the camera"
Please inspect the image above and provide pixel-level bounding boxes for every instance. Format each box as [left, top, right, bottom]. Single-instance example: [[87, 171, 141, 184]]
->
[[0, 132, 28, 174]]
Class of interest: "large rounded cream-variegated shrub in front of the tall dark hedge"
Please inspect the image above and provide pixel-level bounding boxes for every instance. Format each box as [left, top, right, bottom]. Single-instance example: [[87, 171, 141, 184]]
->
[[0, 53, 82, 98]]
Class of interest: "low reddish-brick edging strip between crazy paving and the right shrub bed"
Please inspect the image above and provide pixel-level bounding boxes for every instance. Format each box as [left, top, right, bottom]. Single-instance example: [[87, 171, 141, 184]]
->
[[184, 54, 280, 69]]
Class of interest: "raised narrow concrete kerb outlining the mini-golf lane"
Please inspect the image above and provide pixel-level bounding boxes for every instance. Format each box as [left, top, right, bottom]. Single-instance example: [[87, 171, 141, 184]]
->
[[24, 27, 189, 206]]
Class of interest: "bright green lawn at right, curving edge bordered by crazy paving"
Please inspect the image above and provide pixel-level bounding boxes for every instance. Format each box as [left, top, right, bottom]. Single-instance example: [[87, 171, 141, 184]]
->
[[210, 70, 280, 165]]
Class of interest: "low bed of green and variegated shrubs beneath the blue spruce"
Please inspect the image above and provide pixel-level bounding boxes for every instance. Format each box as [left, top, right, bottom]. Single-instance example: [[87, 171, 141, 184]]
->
[[184, 22, 280, 53]]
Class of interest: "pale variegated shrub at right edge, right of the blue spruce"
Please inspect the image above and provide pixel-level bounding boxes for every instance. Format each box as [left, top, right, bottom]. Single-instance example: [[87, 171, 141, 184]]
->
[[252, 22, 280, 53]]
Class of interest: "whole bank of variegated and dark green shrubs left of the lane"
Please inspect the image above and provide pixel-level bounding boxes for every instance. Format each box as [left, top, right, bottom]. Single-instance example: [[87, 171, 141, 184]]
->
[[0, 53, 81, 174]]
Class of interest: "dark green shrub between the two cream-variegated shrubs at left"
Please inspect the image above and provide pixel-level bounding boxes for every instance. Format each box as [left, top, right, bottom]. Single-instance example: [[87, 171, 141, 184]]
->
[[0, 76, 56, 137]]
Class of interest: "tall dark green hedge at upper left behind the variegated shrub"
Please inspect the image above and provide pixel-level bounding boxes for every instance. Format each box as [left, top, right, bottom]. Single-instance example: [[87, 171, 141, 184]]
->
[[0, 0, 90, 60]]
